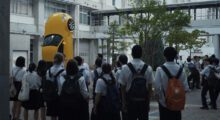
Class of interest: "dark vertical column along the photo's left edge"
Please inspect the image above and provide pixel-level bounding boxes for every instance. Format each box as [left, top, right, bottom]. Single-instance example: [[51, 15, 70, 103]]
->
[[0, 0, 10, 120]]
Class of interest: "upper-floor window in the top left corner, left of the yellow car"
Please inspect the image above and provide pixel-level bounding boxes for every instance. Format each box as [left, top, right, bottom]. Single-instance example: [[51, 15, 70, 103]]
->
[[10, 0, 33, 16]]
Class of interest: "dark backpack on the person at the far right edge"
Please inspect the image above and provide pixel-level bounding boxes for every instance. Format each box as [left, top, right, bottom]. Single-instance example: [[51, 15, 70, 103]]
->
[[207, 67, 219, 88]]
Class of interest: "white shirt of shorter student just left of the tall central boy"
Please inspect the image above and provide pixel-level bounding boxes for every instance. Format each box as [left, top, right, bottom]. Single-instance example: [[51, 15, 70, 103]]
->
[[95, 74, 112, 96]]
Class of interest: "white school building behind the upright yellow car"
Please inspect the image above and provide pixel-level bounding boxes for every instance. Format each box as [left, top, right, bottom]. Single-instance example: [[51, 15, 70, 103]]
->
[[10, 0, 131, 65]]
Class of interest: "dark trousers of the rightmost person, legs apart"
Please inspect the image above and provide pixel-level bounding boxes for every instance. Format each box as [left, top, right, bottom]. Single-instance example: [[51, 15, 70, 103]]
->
[[201, 85, 216, 107]]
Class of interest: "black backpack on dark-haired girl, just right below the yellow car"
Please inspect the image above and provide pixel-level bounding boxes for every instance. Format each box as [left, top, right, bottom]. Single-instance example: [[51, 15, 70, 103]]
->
[[60, 75, 83, 107]]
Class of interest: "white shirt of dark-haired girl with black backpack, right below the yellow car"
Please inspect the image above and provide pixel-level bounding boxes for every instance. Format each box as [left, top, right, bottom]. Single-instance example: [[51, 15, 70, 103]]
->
[[59, 75, 89, 99]]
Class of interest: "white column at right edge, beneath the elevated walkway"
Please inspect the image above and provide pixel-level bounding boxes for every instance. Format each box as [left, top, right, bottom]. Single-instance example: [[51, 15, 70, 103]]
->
[[212, 35, 220, 58]]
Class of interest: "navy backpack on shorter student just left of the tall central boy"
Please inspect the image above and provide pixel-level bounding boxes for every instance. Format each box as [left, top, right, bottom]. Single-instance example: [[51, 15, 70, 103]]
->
[[101, 73, 120, 113]]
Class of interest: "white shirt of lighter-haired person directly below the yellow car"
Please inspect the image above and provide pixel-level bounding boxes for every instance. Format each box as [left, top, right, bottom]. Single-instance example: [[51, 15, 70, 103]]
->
[[46, 65, 65, 94]]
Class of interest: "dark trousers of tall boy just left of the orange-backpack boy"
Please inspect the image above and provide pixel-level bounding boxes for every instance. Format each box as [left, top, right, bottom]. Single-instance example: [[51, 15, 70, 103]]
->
[[127, 102, 149, 120]]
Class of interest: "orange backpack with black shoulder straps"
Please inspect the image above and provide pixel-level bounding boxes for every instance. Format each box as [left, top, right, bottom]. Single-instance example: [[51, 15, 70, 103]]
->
[[161, 65, 186, 111]]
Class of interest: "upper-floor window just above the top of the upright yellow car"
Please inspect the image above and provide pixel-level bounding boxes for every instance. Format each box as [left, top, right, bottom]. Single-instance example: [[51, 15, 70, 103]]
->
[[44, 0, 70, 18]]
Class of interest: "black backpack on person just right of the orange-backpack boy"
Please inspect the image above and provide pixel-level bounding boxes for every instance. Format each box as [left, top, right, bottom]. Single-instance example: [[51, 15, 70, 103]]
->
[[187, 70, 200, 89]]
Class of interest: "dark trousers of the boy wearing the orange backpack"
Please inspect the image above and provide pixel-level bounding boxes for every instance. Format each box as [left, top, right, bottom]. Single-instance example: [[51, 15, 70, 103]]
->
[[159, 104, 182, 120]]
